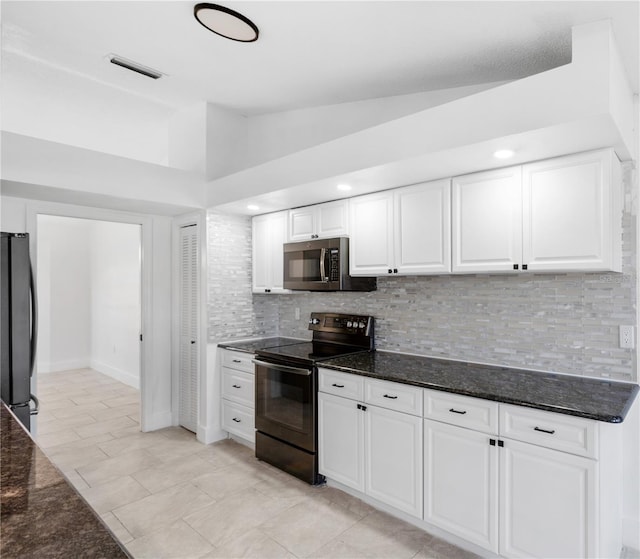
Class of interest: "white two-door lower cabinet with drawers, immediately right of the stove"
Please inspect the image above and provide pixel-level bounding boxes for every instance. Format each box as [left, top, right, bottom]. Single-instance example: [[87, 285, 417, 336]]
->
[[318, 369, 422, 518]]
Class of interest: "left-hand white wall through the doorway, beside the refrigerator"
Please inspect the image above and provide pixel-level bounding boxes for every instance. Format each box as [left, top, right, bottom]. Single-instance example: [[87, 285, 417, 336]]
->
[[37, 215, 91, 373]]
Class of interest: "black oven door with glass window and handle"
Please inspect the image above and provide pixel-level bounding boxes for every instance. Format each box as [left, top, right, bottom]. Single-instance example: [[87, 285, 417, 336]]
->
[[254, 360, 316, 452]]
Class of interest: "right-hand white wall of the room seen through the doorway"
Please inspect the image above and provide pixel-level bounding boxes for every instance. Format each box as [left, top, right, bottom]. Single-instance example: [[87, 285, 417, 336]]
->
[[90, 221, 142, 388]]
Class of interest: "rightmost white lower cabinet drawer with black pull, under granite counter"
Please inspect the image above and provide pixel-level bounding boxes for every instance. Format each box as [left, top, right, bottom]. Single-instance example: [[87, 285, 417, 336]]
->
[[500, 404, 598, 458]]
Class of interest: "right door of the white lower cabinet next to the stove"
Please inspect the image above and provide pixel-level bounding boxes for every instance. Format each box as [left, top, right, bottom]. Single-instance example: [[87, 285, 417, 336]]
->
[[363, 406, 423, 518]]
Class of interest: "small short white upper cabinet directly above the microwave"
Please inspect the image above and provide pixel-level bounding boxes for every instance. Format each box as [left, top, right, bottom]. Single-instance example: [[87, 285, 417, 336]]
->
[[289, 200, 349, 242]]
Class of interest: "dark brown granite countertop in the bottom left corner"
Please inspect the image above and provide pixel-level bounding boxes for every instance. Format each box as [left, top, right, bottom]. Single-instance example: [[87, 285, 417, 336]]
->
[[0, 403, 130, 559]]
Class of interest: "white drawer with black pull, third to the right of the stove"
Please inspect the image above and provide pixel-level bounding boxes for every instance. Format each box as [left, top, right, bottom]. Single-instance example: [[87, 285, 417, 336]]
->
[[424, 390, 498, 435]]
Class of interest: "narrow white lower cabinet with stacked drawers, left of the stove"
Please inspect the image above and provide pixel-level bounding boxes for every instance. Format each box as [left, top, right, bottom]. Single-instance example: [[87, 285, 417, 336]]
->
[[220, 349, 256, 443]]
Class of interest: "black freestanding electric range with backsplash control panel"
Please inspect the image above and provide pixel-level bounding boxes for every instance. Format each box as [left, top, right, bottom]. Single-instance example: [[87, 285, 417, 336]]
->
[[254, 313, 374, 484]]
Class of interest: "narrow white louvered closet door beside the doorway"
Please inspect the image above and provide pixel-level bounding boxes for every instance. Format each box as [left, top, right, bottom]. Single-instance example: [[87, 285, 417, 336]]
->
[[179, 225, 200, 433]]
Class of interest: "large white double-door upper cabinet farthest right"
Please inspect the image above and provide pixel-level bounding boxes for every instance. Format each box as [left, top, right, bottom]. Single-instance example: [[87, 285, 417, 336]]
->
[[452, 149, 622, 273]]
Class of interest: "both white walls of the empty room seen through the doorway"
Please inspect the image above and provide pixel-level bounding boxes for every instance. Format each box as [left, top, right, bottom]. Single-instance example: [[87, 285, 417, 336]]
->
[[37, 214, 142, 422]]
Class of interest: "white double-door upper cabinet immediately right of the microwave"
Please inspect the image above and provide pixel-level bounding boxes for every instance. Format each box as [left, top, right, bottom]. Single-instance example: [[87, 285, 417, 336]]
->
[[350, 179, 451, 276]]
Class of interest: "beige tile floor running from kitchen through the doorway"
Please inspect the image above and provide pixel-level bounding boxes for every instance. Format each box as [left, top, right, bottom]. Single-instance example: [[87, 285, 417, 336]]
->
[[37, 369, 477, 559]]
